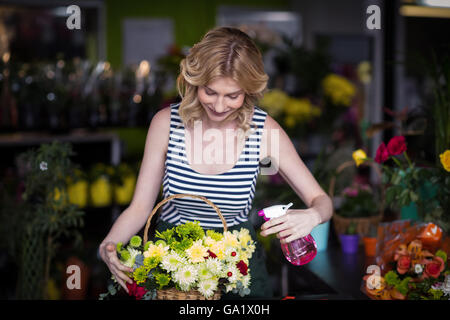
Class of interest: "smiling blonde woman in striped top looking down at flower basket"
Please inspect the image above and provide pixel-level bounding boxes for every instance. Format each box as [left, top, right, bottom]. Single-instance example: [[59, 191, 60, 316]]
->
[[99, 27, 332, 297]]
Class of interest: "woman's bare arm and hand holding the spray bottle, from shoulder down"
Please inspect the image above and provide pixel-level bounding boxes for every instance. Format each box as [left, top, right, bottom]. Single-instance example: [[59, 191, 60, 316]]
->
[[261, 116, 333, 242]]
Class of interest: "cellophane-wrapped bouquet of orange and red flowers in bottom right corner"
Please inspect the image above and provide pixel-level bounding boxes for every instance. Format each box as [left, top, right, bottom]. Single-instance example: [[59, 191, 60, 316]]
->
[[362, 221, 450, 300]]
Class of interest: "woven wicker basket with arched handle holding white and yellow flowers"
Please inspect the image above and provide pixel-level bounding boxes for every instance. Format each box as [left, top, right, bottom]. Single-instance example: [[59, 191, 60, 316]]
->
[[144, 193, 228, 300]]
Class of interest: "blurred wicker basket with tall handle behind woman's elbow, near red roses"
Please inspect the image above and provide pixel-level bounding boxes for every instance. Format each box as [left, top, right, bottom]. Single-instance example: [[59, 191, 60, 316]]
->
[[328, 160, 385, 243]]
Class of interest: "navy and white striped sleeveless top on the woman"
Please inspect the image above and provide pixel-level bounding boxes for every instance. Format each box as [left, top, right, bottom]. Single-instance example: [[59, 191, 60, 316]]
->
[[159, 103, 267, 228]]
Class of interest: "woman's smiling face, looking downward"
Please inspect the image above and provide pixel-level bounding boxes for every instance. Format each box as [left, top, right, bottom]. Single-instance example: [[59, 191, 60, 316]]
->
[[197, 77, 245, 122]]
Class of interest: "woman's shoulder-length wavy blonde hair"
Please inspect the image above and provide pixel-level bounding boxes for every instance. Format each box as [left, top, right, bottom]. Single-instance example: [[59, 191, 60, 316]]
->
[[177, 27, 269, 136]]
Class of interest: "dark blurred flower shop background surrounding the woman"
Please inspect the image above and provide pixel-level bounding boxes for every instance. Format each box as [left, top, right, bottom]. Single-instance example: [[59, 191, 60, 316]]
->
[[0, 0, 450, 300]]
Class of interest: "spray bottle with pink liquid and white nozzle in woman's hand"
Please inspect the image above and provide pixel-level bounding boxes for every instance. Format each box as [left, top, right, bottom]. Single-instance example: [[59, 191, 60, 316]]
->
[[258, 202, 317, 266]]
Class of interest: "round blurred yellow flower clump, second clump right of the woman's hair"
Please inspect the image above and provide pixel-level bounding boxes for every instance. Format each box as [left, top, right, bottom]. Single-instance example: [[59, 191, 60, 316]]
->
[[322, 74, 356, 107]]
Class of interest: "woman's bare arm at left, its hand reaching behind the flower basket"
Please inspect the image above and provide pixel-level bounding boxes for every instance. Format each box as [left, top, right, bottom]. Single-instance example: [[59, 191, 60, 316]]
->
[[99, 108, 170, 291]]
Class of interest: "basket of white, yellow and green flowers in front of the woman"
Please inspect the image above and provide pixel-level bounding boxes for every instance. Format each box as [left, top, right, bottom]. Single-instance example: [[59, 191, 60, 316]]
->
[[100, 194, 255, 300]]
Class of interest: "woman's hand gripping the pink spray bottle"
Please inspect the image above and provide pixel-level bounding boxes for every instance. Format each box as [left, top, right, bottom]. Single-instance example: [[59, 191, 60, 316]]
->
[[261, 208, 321, 243]]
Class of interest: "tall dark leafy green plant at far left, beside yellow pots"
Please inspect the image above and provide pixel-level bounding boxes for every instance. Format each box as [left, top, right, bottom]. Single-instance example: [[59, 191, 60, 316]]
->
[[16, 142, 84, 298]]
